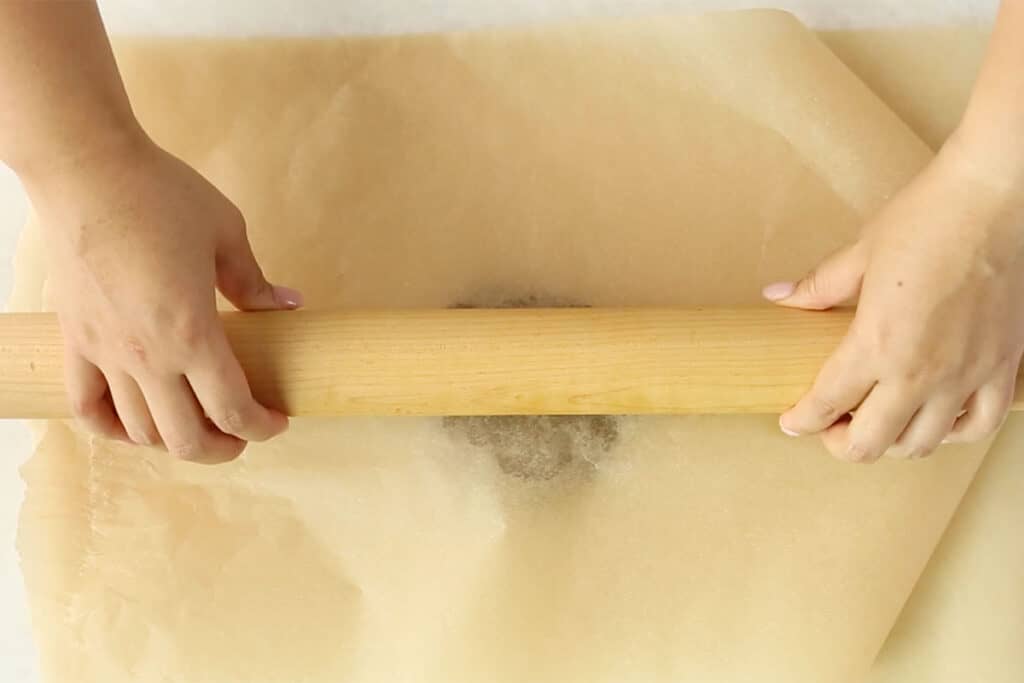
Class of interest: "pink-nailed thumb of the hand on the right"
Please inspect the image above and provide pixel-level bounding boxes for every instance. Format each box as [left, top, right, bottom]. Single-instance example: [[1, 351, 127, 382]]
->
[[762, 242, 867, 310]]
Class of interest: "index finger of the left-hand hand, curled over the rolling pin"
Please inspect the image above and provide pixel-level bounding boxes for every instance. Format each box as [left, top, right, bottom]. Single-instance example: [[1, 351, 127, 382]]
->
[[187, 335, 288, 441]]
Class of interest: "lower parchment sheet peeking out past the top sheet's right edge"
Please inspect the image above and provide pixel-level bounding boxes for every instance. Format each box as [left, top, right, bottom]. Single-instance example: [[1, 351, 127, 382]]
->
[[822, 26, 1024, 683]]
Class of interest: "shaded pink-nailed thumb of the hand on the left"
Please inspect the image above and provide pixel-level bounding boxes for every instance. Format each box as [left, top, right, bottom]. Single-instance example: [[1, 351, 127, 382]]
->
[[217, 230, 302, 310]]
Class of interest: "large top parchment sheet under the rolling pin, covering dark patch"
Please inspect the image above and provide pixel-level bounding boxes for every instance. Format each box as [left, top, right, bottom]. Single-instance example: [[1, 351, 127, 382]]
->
[[8, 12, 1011, 683]]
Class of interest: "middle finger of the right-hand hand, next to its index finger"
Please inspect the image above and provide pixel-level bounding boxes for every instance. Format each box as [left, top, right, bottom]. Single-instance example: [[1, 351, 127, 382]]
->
[[837, 384, 922, 463]]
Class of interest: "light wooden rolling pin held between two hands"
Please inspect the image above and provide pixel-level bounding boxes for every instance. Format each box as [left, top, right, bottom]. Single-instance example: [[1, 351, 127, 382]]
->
[[0, 307, 1024, 418]]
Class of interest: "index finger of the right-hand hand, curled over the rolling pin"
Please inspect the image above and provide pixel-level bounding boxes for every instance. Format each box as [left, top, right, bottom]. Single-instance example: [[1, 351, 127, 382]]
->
[[779, 340, 874, 436]]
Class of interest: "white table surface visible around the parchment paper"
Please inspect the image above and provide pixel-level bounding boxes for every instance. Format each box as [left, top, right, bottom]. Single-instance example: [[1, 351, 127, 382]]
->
[[0, 0, 996, 683]]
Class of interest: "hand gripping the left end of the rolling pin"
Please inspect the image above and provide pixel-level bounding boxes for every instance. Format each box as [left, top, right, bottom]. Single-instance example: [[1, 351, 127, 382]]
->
[[28, 136, 301, 462]]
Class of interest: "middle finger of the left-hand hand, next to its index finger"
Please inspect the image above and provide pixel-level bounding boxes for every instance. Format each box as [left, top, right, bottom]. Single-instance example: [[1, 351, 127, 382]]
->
[[141, 375, 246, 464]]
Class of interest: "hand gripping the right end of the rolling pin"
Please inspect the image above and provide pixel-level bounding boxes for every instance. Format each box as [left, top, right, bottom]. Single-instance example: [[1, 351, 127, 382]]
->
[[765, 135, 1024, 463]]
